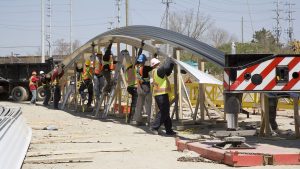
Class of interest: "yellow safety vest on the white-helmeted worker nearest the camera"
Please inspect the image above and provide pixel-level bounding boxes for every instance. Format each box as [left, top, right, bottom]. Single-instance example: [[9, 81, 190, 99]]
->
[[152, 69, 171, 96]]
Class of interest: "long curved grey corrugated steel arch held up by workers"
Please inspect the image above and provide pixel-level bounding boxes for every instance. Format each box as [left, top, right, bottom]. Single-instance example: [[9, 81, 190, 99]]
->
[[63, 25, 225, 68]]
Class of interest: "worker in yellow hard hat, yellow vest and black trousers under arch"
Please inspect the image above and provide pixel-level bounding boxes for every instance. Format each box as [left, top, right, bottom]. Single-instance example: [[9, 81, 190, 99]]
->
[[79, 59, 93, 107]]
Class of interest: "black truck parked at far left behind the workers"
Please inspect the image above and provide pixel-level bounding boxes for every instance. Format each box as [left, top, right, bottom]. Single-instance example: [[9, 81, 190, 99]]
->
[[0, 58, 54, 101]]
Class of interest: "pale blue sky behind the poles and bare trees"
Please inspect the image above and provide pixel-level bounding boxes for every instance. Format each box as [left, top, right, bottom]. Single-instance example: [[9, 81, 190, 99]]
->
[[0, 0, 300, 56]]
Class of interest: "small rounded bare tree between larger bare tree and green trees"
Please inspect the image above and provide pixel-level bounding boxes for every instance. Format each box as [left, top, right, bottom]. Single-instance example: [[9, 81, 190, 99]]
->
[[207, 28, 236, 47]]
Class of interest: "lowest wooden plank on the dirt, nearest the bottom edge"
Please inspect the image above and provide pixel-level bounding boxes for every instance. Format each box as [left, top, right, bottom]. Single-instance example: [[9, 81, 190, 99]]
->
[[24, 157, 93, 164]]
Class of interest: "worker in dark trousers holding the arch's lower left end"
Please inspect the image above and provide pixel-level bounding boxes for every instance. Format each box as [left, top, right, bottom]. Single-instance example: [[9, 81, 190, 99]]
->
[[51, 64, 64, 110]]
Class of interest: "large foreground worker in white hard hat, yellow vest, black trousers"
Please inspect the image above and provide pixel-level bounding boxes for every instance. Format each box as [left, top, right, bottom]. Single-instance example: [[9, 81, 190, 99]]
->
[[150, 58, 177, 135]]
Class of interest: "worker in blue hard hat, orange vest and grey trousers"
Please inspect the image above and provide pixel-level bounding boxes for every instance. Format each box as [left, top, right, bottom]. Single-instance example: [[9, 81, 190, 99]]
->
[[132, 54, 152, 126]]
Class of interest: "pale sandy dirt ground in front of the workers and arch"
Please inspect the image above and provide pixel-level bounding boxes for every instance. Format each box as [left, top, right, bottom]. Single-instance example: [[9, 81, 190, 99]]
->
[[0, 102, 300, 169]]
